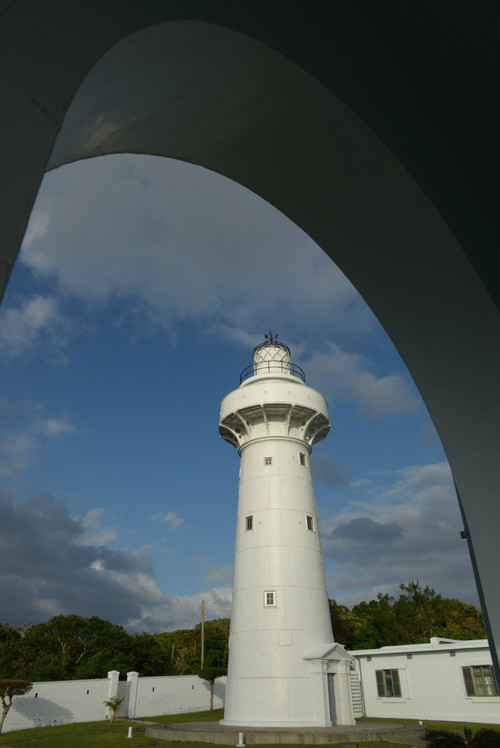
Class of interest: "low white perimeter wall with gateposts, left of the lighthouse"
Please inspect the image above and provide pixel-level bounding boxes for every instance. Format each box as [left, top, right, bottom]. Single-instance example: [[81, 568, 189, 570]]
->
[[3, 671, 226, 733]]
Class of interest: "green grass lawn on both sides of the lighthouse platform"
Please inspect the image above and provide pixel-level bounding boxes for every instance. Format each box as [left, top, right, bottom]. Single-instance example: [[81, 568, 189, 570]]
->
[[0, 709, 500, 748]]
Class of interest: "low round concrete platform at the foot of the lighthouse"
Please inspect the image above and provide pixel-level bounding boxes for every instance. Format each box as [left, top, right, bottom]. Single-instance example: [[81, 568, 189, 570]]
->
[[146, 722, 425, 746]]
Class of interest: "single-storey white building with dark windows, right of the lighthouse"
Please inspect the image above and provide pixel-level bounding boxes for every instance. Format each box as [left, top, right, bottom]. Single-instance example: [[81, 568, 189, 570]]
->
[[350, 637, 500, 724]]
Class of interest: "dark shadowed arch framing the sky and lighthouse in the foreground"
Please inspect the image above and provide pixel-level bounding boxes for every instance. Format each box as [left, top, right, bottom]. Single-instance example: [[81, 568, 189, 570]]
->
[[0, 0, 500, 672]]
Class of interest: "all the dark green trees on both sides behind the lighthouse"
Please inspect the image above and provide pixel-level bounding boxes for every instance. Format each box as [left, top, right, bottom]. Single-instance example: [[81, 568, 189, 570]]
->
[[0, 581, 486, 681]]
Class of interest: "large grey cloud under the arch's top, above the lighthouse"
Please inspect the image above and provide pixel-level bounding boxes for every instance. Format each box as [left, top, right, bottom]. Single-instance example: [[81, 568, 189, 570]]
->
[[20, 155, 376, 348]]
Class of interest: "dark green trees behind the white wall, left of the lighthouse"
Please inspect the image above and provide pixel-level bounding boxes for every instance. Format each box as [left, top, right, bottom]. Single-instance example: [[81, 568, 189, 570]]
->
[[0, 615, 229, 681]]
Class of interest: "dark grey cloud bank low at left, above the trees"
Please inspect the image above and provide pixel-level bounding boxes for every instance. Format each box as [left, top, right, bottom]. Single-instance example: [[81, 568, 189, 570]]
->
[[0, 490, 174, 625]]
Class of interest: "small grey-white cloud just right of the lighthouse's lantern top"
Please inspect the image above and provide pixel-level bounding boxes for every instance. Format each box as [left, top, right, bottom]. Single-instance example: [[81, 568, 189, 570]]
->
[[304, 342, 421, 418]]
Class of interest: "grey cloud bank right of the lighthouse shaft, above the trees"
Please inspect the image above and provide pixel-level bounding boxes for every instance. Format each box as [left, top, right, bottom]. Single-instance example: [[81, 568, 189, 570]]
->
[[321, 463, 477, 604]]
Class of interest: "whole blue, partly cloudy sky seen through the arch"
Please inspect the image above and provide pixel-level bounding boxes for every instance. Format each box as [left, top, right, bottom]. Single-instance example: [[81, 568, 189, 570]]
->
[[0, 155, 477, 631]]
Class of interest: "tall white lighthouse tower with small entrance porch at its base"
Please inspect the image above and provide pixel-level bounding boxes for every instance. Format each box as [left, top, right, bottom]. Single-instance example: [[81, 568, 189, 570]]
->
[[219, 334, 355, 727]]
